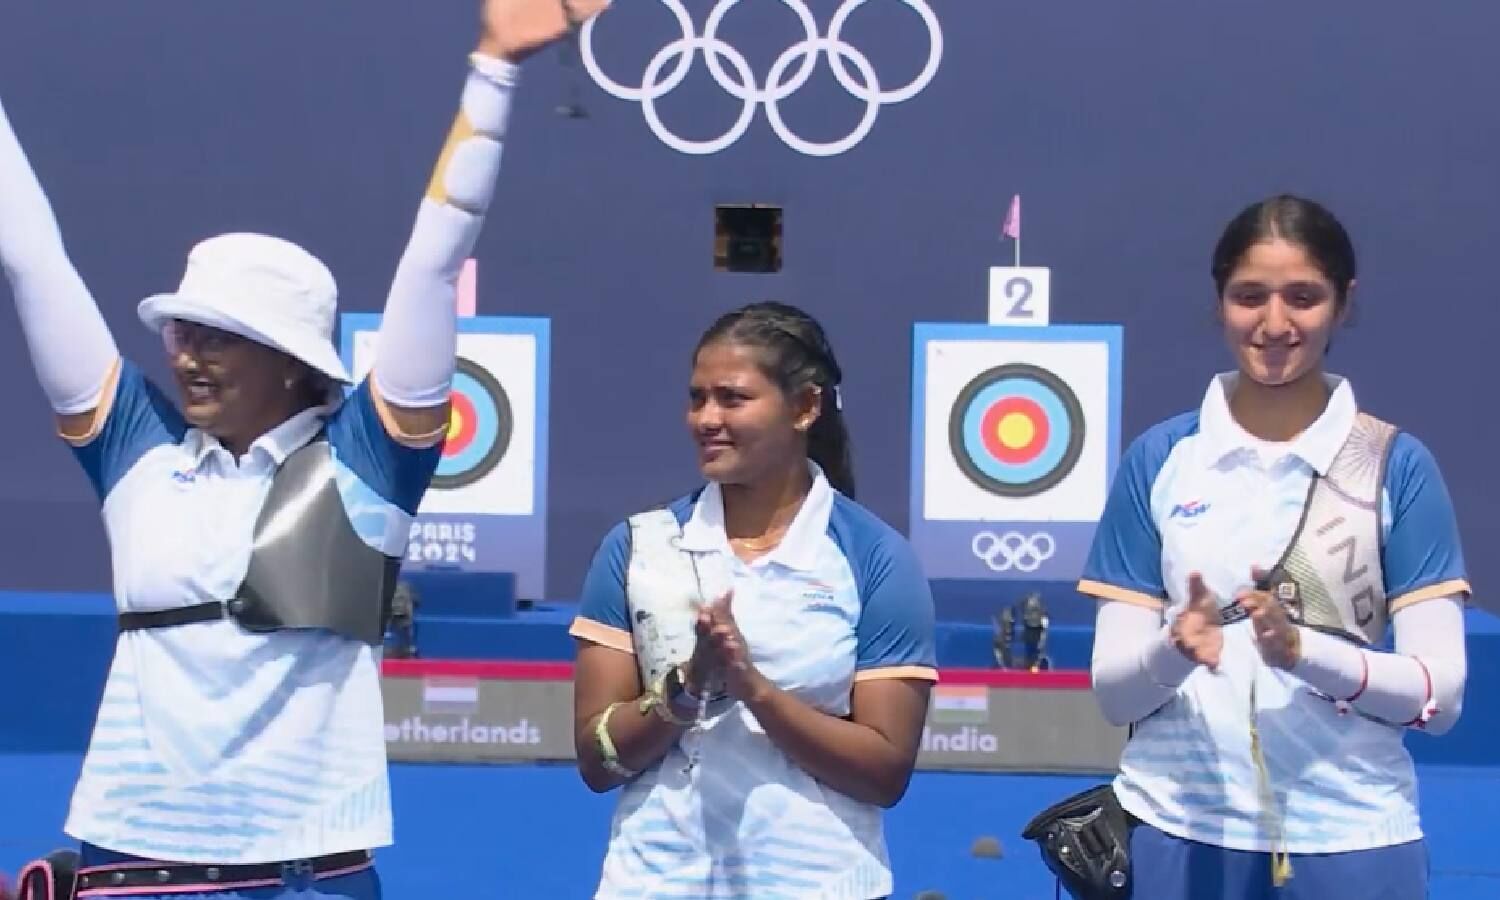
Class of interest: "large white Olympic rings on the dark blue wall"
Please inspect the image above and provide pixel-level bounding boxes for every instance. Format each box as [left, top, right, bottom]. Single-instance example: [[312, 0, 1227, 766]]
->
[[579, 0, 942, 156]]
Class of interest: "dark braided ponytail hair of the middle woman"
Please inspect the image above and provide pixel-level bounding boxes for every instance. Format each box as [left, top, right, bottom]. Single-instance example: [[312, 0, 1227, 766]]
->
[[693, 302, 854, 500]]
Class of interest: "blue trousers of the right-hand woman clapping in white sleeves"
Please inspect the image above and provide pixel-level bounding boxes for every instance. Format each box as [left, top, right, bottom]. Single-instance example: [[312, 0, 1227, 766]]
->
[[1130, 824, 1428, 900]]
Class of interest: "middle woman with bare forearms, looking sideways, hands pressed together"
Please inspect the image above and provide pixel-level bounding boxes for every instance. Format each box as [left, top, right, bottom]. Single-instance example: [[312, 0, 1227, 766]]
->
[[572, 303, 936, 900]]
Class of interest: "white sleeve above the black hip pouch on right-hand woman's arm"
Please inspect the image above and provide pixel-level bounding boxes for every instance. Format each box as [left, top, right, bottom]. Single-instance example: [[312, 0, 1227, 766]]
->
[[1091, 600, 1197, 725]]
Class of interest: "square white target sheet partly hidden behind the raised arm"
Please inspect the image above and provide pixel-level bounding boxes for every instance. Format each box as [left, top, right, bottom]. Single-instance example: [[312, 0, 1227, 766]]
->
[[353, 332, 537, 516]]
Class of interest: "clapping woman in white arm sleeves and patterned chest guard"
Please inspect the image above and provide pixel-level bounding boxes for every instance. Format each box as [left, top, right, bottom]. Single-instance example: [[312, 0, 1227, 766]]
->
[[1079, 197, 1469, 900]]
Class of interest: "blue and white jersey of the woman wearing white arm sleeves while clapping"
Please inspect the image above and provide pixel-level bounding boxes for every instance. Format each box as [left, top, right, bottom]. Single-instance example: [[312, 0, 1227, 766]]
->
[[1079, 375, 1469, 854]]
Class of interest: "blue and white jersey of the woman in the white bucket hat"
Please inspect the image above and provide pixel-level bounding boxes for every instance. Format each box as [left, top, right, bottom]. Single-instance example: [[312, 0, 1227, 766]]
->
[[66, 363, 440, 864]]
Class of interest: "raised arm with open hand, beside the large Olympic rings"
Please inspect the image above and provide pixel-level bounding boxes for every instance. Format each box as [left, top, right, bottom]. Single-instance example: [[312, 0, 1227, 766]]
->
[[372, 0, 608, 446]]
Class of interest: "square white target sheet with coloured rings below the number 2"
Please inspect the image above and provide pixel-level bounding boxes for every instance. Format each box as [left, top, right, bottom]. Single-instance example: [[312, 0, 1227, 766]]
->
[[923, 339, 1109, 522]]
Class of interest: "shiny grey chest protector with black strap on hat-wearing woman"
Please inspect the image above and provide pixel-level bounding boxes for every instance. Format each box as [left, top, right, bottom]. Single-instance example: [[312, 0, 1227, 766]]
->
[[120, 435, 401, 647]]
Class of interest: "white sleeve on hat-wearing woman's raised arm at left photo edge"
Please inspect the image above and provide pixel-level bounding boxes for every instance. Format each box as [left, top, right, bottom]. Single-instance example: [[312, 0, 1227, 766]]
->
[[0, 98, 120, 416]]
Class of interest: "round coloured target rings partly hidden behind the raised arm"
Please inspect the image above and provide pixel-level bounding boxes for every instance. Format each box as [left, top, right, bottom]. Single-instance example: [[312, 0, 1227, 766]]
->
[[432, 357, 515, 491]]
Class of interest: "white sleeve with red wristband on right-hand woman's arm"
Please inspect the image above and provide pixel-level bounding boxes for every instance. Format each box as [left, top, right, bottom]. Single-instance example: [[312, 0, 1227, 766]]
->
[[1293, 597, 1469, 735]]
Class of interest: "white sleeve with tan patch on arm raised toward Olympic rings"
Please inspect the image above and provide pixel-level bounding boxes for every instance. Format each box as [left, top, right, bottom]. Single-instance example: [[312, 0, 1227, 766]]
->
[[372, 54, 519, 410]]
